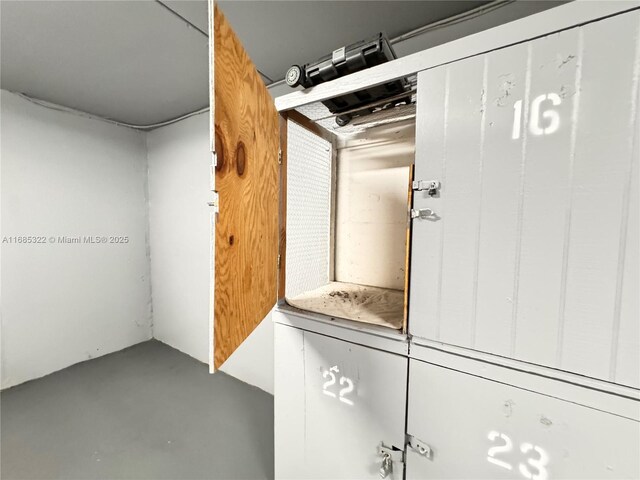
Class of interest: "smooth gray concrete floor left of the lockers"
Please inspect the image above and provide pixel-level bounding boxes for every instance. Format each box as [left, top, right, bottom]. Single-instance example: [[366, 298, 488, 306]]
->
[[0, 341, 273, 480]]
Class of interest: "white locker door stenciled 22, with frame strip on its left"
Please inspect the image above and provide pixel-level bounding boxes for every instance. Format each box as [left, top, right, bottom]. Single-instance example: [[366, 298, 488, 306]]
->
[[275, 324, 408, 480]]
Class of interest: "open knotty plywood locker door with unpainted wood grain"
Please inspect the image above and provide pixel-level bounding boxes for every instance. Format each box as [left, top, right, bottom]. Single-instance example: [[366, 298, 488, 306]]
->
[[211, 6, 279, 369]]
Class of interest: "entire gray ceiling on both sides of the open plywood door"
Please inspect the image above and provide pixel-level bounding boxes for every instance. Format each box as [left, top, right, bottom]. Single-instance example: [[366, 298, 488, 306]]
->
[[0, 0, 556, 125]]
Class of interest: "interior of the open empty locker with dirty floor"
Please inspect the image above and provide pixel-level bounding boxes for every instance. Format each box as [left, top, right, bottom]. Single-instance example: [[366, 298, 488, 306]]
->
[[281, 96, 415, 332]]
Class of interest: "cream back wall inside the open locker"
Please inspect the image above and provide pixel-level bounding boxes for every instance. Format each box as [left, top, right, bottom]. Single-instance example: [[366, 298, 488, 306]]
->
[[335, 137, 415, 290]]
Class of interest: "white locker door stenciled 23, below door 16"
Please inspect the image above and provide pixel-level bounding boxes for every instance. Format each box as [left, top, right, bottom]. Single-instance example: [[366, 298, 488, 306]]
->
[[406, 360, 640, 480]]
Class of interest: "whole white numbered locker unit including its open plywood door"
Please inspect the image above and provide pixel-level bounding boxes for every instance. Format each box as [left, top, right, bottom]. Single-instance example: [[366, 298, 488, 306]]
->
[[211, 2, 640, 480]]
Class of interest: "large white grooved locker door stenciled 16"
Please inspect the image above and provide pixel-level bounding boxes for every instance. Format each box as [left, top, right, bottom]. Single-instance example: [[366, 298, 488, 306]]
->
[[409, 10, 640, 387]]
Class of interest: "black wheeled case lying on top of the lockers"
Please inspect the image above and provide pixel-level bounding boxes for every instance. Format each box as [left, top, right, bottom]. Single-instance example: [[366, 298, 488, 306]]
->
[[285, 33, 411, 126]]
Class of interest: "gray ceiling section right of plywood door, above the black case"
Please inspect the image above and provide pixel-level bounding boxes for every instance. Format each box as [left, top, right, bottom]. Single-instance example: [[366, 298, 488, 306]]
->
[[218, 0, 487, 80]]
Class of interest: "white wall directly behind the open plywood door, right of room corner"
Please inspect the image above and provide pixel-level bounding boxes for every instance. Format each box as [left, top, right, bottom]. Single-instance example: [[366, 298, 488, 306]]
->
[[147, 114, 273, 393]]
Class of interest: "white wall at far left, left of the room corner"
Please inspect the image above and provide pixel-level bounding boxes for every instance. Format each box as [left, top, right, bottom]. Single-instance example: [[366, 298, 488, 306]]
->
[[0, 91, 151, 388]]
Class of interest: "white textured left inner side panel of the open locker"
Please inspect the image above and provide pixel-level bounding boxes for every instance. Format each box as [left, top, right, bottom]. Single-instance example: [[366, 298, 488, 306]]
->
[[285, 120, 332, 297]]
